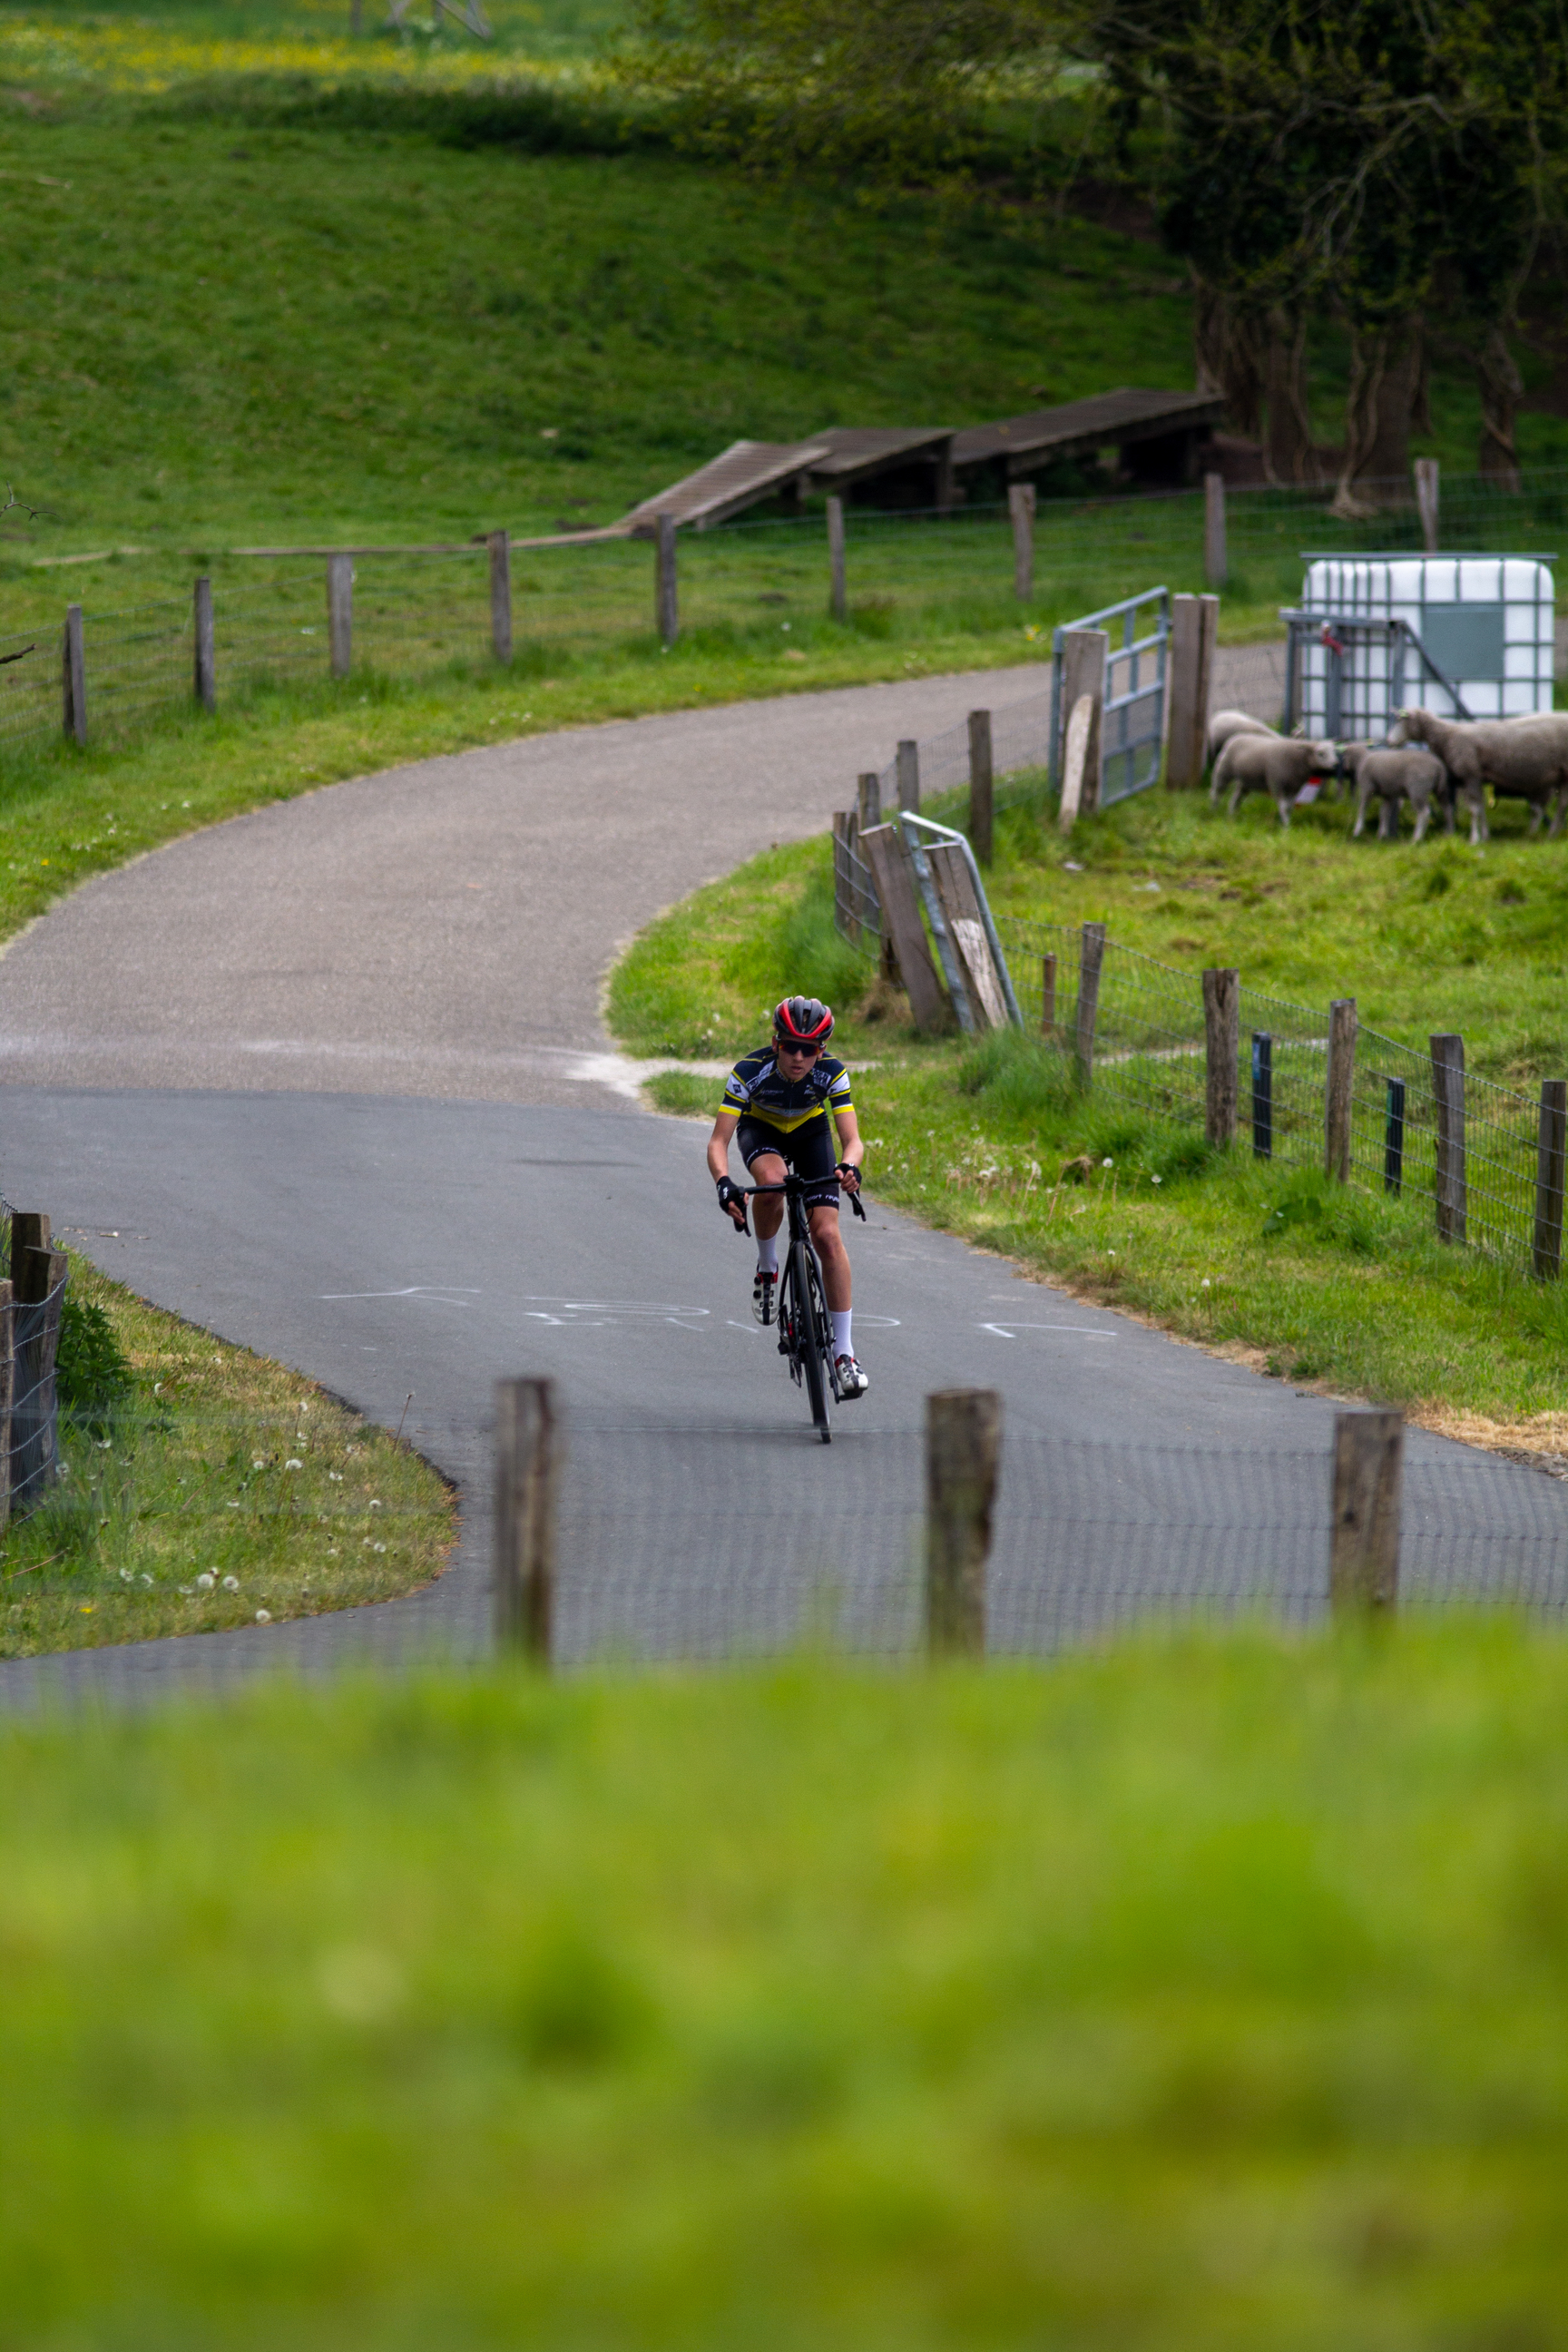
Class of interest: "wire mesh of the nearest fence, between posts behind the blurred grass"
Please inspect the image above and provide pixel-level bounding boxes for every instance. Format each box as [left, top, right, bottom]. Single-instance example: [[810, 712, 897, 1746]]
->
[[0, 1406, 1568, 1705]]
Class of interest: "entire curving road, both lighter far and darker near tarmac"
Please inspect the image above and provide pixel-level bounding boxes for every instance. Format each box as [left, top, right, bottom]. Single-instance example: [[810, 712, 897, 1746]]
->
[[0, 666, 1568, 1703]]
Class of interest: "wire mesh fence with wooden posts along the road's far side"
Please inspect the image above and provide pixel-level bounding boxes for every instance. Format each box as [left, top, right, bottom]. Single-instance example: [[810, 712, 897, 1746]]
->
[[0, 468, 1568, 771]]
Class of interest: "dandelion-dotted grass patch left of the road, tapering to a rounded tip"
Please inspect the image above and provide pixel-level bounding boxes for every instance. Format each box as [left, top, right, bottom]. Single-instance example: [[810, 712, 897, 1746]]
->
[[0, 1254, 456, 1658]]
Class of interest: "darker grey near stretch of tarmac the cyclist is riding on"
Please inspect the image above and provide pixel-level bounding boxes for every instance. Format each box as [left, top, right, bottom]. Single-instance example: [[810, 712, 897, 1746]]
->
[[0, 1089, 1568, 1703]]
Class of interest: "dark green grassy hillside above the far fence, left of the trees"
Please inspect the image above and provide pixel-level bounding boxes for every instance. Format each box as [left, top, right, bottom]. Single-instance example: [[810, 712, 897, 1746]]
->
[[0, 0, 1547, 578]]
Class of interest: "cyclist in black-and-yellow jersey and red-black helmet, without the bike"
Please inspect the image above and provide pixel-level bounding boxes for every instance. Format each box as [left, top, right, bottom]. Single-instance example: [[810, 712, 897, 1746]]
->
[[708, 997, 872, 1397]]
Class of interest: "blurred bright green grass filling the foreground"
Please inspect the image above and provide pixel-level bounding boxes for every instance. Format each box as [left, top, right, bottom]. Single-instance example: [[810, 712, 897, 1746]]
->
[[0, 1621, 1568, 2352]]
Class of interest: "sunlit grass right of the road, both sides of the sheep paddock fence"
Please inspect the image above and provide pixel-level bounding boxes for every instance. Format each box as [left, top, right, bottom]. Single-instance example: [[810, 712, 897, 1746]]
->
[[609, 793, 1568, 1454]]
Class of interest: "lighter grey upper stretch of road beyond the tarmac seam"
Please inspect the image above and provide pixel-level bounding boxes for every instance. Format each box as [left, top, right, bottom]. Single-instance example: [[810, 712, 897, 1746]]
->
[[0, 663, 1048, 1103]]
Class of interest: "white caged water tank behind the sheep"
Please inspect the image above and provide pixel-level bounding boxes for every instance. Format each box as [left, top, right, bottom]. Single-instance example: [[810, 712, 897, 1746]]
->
[[1300, 555, 1556, 734]]
